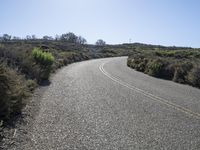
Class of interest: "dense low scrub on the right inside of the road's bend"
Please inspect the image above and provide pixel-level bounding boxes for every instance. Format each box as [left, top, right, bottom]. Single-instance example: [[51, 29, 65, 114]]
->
[[127, 46, 200, 88]]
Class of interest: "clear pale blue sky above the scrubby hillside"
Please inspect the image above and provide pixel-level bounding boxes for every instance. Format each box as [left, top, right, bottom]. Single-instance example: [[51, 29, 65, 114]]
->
[[0, 0, 200, 47]]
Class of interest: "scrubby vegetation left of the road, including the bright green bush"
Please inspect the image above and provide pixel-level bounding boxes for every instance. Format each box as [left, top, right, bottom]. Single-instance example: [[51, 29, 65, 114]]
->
[[0, 32, 131, 127]]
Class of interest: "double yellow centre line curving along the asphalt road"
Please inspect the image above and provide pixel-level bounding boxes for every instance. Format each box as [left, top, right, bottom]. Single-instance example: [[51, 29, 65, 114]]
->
[[99, 61, 200, 119]]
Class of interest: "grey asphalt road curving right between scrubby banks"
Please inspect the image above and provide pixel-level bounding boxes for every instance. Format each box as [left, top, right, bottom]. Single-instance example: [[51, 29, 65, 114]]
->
[[21, 57, 200, 150]]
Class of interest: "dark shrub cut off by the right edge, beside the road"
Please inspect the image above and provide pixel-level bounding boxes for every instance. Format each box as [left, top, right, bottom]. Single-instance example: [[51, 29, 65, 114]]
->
[[188, 67, 200, 87]]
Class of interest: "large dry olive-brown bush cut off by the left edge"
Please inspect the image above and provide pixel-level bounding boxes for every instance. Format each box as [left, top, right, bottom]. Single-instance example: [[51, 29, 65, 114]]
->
[[0, 65, 27, 120]]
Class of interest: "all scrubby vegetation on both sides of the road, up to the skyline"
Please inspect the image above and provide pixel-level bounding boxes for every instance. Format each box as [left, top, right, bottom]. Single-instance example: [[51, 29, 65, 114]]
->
[[0, 32, 200, 135]]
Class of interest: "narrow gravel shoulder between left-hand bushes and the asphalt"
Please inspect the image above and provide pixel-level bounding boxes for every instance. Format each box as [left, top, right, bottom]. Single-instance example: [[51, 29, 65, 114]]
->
[[0, 86, 48, 150]]
